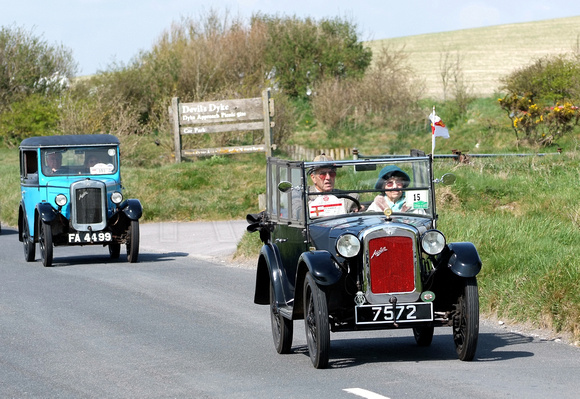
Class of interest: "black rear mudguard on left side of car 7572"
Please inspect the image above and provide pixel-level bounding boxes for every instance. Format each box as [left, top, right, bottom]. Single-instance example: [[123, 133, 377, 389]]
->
[[254, 244, 294, 306]]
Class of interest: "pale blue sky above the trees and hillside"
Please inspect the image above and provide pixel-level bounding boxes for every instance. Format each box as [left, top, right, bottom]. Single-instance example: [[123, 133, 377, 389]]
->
[[0, 0, 580, 76]]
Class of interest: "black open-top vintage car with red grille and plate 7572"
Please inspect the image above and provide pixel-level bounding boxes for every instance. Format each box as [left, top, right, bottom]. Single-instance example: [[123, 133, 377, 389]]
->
[[248, 151, 481, 368]]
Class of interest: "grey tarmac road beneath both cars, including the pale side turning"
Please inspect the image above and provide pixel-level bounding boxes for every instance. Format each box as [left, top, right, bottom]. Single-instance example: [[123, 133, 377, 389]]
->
[[0, 222, 580, 399]]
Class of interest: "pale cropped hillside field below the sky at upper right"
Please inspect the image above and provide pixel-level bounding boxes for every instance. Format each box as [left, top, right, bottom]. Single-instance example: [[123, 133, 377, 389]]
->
[[366, 16, 580, 98]]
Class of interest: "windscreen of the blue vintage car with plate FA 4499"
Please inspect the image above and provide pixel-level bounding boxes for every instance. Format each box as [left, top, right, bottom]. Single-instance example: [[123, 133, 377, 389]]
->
[[40, 146, 118, 176]]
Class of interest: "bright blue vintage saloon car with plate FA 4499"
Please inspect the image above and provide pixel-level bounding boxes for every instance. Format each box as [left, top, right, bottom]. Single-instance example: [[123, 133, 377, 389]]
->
[[18, 134, 143, 267]]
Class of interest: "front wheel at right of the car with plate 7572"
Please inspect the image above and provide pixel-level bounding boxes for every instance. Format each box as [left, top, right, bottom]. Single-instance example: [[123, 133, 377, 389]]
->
[[453, 277, 479, 361]]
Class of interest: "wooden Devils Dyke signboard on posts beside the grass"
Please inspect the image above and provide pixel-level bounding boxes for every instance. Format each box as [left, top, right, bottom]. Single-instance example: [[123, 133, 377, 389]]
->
[[170, 89, 274, 163]]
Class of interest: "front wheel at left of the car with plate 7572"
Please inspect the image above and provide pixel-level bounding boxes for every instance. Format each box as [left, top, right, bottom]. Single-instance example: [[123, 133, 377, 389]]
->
[[304, 272, 330, 369]]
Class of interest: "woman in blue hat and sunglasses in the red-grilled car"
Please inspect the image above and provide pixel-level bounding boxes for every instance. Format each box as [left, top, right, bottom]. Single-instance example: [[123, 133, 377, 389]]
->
[[368, 165, 411, 212]]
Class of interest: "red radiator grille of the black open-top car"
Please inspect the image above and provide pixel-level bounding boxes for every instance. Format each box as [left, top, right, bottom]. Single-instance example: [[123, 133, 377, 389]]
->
[[368, 236, 415, 294]]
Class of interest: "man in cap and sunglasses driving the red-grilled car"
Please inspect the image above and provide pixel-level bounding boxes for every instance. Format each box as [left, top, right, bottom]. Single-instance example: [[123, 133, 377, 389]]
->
[[308, 153, 362, 217]]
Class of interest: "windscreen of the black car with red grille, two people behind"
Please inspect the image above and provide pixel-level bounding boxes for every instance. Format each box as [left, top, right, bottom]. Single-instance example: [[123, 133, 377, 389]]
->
[[307, 158, 434, 219]]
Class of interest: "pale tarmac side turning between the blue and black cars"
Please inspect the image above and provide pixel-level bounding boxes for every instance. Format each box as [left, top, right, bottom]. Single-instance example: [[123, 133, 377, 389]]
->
[[139, 220, 249, 264]]
